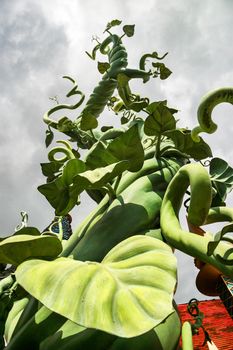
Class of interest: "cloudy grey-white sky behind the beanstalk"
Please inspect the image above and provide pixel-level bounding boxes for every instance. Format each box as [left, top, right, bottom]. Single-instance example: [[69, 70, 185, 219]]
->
[[0, 0, 233, 302]]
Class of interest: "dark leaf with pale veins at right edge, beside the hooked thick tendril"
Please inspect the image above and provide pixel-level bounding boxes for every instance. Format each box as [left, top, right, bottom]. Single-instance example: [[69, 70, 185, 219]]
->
[[210, 158, 233, 201]]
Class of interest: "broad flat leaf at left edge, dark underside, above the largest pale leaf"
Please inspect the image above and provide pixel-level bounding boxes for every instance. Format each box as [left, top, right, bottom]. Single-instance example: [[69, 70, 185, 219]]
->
[[0, 234, 62, 265]]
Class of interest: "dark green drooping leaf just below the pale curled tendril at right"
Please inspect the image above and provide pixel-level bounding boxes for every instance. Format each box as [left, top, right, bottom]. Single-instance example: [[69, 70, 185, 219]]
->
[[165, 129, 212, 160]]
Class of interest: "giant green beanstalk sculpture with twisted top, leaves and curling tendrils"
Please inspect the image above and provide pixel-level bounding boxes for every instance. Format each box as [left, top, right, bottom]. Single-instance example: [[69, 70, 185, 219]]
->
[[0, 20, 233, 350]]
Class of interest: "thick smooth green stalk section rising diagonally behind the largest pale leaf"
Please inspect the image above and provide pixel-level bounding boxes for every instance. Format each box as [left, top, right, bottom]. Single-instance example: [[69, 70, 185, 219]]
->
[[71, 161, 180, 261]]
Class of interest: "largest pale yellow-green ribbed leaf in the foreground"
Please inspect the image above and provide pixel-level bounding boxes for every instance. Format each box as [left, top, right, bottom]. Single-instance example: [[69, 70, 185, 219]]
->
[[16, 235, 176, 337]]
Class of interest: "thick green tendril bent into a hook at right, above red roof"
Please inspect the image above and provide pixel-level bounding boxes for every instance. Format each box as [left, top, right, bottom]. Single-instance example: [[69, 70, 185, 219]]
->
[[160, 164, 233, 277]]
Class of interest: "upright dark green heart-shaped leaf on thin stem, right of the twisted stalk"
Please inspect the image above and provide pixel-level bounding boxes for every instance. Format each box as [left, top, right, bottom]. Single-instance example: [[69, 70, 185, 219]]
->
[[144, 102, 176, 136]]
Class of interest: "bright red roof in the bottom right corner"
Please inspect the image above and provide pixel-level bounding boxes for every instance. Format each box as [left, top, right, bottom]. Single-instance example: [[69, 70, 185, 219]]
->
[[178, 299, 233, 350]]
